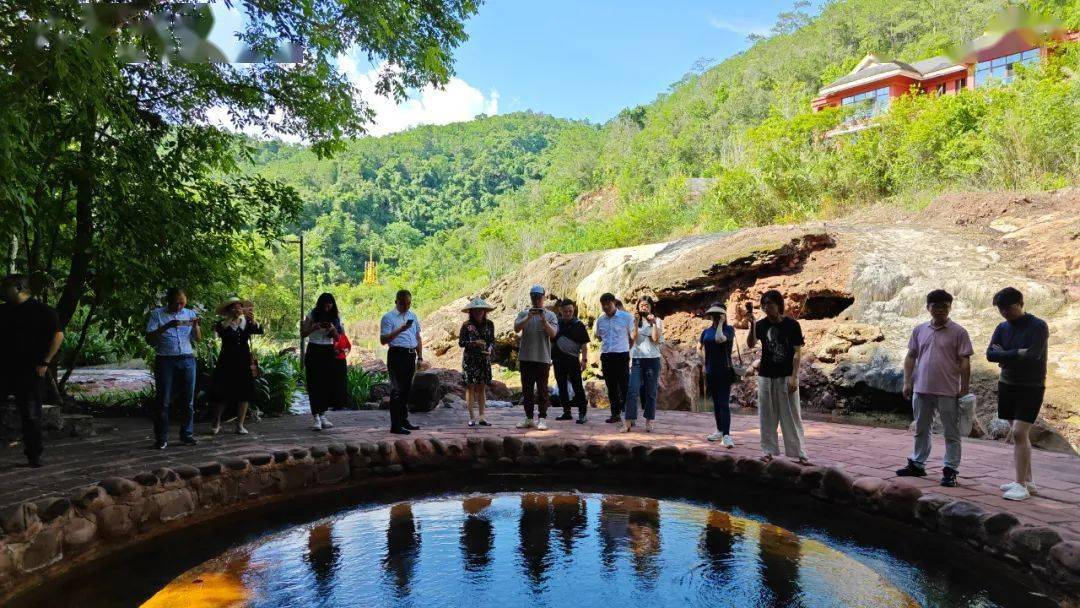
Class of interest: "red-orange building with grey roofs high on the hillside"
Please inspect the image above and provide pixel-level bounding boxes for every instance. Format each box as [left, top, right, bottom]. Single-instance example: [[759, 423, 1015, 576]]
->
[[812, 29, 1080, 135]]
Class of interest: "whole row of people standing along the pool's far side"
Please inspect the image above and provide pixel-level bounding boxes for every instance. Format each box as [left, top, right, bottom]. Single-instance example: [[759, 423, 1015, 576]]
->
[[0, 274, 1049, 500]]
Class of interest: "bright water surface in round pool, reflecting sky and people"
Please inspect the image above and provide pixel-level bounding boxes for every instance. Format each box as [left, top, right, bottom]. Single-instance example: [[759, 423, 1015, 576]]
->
[[137, 492, 1036, 608]]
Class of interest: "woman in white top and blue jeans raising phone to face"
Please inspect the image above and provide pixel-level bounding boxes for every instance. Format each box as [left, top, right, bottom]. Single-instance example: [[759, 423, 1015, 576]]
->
[[623, 296, 664, 433]]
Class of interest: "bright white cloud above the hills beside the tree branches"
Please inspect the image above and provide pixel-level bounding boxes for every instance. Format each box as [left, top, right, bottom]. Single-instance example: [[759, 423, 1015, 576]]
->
[[338, 56, 499, 135]]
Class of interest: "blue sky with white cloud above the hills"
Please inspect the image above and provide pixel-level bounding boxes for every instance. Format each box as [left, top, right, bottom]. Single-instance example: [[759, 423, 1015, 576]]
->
[[213, 0, 819, 135]]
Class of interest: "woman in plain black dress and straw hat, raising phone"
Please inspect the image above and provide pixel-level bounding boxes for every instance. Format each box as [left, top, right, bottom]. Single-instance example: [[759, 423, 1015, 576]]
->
[[211, 297, 262, 435]]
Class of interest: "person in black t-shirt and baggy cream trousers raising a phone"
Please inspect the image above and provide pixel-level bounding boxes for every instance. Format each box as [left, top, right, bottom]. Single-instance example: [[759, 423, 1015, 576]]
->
[[746, 289, 810, 464]]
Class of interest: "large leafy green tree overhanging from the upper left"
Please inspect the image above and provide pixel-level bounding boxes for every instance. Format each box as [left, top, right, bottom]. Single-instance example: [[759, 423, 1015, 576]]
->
[[0, 0, 477, 380]]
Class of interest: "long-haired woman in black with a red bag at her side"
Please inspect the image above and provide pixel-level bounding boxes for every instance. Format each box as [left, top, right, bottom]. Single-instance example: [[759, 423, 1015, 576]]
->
[[300, 293, 349, 431]]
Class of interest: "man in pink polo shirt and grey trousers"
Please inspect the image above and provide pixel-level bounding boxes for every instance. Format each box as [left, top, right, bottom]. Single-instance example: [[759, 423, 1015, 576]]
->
[[896, 289, 974, 487]]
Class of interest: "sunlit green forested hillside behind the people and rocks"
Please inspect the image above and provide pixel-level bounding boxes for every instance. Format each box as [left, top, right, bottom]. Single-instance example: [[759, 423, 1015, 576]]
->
[[253, 0, 1080, 332]]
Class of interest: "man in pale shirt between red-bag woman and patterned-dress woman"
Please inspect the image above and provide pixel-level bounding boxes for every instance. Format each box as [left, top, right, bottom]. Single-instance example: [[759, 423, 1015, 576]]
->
[[379, 289, 423, 435]]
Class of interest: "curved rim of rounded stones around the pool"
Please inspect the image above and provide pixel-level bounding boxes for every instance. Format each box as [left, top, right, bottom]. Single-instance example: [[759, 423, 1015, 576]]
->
[[0, 436, 1080, 608]]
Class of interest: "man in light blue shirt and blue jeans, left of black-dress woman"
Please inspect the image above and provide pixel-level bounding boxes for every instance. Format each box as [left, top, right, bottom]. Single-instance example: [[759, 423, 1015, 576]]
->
[[146, 287, 202, 449]]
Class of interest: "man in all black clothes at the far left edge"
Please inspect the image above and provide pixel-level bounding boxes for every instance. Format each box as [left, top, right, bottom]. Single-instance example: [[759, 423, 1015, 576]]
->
[[0, 274, 64, 467]]
